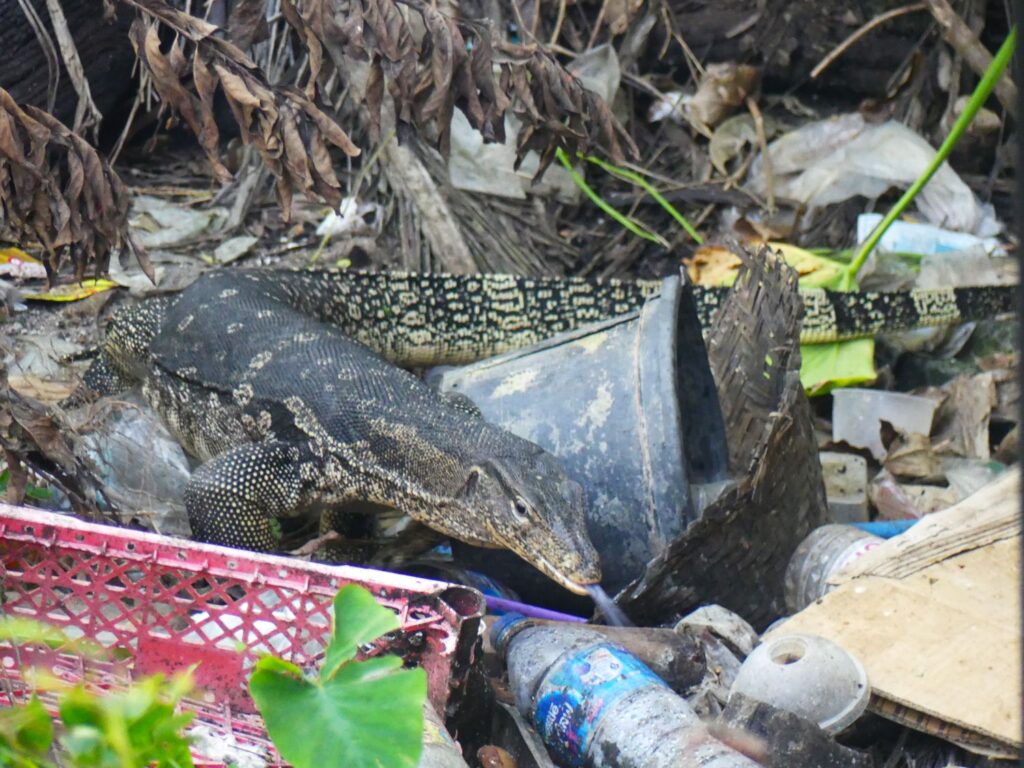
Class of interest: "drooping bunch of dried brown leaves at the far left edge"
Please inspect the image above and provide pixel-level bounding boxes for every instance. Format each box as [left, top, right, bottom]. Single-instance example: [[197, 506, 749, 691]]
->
[[0, 88, 152, 284]]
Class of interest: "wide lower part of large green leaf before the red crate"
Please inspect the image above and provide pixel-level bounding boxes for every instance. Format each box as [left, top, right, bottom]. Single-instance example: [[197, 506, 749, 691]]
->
[[249, 651, 427, 768]]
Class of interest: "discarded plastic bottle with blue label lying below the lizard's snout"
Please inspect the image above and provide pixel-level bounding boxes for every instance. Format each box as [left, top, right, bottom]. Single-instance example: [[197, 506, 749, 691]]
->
[[490, 614, 757, 768]]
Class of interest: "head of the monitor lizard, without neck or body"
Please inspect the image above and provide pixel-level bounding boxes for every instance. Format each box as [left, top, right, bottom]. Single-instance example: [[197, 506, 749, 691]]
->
[[460, 454, 601, 595]]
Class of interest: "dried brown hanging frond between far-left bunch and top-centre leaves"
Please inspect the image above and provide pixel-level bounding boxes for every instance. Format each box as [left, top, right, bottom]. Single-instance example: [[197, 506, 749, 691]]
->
[[123, 0, 359, 218]]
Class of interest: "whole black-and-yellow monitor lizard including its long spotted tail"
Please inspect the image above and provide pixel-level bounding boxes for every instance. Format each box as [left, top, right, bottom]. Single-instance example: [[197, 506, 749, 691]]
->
[[86, 270, 1014, 585]]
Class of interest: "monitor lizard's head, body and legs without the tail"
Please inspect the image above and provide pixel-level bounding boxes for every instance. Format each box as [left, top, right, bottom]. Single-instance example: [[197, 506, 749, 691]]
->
[[87, 272, 600, 594]]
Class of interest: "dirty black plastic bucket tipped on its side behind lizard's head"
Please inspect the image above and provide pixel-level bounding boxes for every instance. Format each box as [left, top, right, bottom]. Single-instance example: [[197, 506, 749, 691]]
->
[[427, 276, 728, 602]]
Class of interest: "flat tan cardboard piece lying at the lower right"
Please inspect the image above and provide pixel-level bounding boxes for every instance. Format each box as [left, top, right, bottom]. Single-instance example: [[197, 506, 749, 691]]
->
[[768, 469, 1022, 758]]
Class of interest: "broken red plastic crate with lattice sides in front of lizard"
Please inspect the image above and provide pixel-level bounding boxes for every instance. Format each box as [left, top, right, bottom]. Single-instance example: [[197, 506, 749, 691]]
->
[[0, 504, 484, 766]]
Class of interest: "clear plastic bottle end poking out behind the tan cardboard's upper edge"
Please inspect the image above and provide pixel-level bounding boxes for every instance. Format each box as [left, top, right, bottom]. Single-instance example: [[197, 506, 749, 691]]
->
[[785, 525, 884, 613]]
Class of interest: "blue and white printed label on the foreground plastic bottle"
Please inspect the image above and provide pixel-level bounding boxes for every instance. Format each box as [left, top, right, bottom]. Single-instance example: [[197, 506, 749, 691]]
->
[[534, 643, 668, 768]]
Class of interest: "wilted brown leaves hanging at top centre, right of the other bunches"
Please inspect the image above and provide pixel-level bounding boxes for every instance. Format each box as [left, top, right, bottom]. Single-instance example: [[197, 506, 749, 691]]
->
[[282, 0, 637, 172]]
